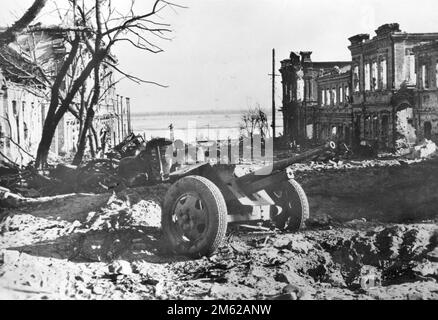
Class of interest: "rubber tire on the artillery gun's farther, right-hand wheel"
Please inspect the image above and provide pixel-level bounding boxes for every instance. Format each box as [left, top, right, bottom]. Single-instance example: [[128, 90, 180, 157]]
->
[[269, 179, 310, 232]]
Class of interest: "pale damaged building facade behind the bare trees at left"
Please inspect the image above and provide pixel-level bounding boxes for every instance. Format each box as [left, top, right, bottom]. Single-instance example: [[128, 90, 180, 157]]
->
[[0, 27, 131, 165]]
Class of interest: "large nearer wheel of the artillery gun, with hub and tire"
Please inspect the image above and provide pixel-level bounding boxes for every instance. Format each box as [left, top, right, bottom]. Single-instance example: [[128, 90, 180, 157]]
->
[[161, 176, 227, 257]]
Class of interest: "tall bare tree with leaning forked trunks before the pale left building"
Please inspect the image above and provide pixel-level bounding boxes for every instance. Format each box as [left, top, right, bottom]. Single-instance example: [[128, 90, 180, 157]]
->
[[31, 0, 181, 166]]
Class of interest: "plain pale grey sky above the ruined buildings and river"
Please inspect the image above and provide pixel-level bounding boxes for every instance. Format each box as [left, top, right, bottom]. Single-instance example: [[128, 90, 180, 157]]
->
[[0, 0, 438, 112]]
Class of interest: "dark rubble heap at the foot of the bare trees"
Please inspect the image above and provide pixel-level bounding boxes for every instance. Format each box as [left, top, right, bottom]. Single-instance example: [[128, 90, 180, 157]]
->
[[0, 134, 149, 198]]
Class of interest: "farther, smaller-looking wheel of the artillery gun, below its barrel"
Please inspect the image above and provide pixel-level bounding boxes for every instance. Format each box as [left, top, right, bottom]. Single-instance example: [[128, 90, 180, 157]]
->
[[268, 179, 309, 231]]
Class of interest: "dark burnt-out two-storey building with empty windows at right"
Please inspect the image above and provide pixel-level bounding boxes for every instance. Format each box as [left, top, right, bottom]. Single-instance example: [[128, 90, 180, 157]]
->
[[280, 24, 438, 150]]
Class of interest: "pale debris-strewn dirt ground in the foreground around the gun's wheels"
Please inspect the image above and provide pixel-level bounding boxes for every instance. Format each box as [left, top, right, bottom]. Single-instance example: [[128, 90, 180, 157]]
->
[[0, 161, 438, 299]]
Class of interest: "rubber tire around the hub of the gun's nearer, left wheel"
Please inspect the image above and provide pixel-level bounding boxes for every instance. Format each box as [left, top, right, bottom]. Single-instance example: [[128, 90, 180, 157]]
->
[[161, 176, 228, 258]]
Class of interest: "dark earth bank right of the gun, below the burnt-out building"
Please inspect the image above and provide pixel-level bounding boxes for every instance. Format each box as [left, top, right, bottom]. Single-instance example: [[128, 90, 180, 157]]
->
[[295, 158, 438, 223]]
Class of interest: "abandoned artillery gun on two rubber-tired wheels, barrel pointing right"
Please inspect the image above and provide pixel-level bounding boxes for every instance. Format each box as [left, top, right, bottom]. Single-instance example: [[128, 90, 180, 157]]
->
[[137, 141, 336, 257]]
